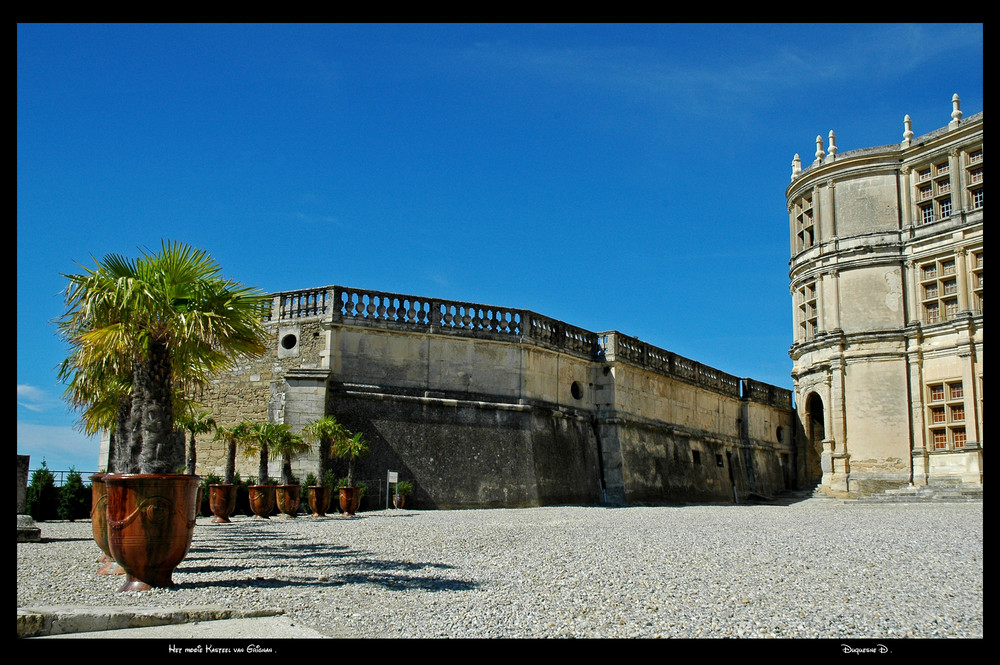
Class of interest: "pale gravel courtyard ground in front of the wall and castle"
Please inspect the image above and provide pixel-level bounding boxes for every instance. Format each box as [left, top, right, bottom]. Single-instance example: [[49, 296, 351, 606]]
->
[[17, 499, 983, 639]]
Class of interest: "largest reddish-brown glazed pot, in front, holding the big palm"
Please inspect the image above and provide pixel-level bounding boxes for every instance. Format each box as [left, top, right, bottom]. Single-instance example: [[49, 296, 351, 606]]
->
[[104, 473, 201, 591]]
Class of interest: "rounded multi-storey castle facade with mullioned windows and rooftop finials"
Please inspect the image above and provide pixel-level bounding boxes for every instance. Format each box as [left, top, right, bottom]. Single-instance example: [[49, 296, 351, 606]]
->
[[785, 95, 983, 496]]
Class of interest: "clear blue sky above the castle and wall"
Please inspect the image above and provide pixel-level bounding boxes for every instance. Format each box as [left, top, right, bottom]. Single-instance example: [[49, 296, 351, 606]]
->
[[17, 23, 983, 471]]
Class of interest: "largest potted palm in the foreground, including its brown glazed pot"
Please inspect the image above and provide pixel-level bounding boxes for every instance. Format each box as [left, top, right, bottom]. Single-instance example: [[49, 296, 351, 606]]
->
[[57, 241, 270, 591]]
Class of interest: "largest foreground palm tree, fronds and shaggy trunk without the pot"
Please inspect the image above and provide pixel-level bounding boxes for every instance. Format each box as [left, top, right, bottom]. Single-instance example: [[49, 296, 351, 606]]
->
[[57, 241, 270, 473]]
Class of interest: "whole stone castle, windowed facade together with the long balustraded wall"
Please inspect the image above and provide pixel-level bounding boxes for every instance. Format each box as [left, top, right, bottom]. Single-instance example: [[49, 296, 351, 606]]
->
[[101, 96, 983, 508]]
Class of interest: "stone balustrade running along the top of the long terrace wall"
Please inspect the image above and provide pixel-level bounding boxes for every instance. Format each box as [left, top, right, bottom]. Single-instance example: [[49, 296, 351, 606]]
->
[[267, 286, 791, 408]]
